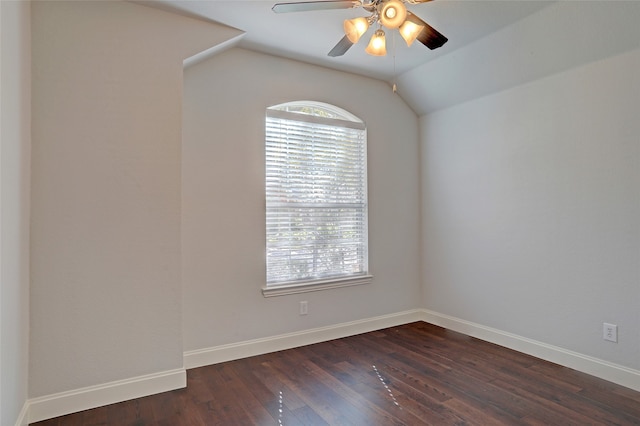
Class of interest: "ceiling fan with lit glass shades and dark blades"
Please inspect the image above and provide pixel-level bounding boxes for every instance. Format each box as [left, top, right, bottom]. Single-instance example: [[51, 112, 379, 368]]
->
[[272, 0, 447, 57]]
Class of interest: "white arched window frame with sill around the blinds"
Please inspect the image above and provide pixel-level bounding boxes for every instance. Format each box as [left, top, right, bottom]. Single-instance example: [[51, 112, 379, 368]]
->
[[262, 101, 373, 297]]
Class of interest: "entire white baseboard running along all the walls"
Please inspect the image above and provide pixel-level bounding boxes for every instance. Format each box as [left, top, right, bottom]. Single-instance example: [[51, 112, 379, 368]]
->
[[23, 309, 640, 426]]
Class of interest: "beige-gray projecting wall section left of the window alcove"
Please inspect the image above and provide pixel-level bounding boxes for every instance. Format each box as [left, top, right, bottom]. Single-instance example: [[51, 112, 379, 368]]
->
[[29, 1, 236, 397]]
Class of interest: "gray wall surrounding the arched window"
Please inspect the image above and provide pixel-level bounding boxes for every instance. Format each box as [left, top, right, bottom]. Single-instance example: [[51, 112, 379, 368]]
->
[[182, 49, 420, 351]]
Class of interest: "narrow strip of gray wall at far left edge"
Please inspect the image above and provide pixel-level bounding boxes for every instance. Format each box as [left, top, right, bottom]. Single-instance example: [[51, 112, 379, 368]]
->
[[0, 1, 31, 425]]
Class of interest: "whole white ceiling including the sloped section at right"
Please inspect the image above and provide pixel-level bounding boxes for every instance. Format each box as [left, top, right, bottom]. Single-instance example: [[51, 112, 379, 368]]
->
[[140, 0, 640, 115]]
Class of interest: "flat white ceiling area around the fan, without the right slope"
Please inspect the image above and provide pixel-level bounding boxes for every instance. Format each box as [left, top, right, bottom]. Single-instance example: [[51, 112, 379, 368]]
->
[[146, 0, 549, 80]]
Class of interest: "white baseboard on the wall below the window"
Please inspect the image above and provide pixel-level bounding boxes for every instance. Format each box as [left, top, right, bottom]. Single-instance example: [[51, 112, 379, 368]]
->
[[184, 309, 424, 369]]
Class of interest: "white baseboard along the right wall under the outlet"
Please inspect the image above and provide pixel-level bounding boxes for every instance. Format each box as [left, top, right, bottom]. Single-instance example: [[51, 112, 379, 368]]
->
[[422, 309, 640, 391]]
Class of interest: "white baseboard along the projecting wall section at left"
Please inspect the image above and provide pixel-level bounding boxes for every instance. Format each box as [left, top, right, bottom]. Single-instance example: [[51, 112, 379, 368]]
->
[[28, 368, 187, 426]]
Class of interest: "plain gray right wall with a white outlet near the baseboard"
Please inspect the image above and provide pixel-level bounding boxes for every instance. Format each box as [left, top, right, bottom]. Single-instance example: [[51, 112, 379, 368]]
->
[[421, 50, 640, 369]]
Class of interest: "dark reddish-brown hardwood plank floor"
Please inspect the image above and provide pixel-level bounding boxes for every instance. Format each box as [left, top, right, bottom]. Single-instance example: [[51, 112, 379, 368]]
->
[[35, 322, 640, 426]]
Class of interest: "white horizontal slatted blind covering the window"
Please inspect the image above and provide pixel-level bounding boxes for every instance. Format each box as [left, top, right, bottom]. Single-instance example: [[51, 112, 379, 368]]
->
[[265, 104, 368, 286]]
